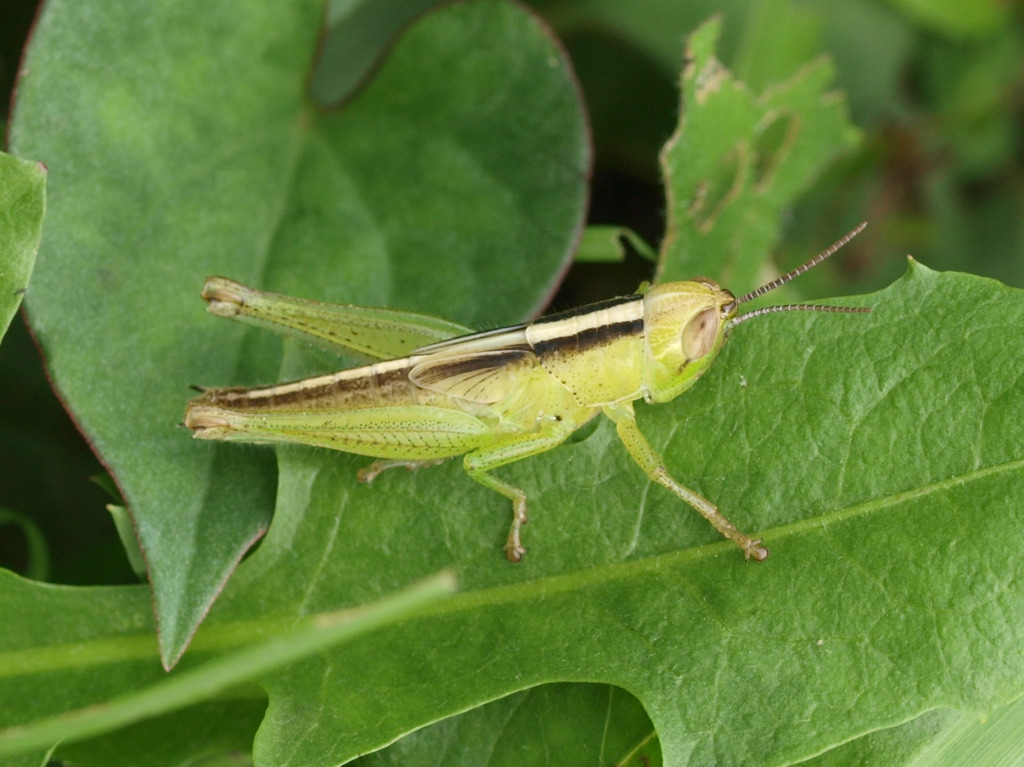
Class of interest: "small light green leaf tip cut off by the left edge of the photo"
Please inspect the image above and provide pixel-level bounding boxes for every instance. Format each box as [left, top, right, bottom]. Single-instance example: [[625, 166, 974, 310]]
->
[[0, 153, 46, 339]]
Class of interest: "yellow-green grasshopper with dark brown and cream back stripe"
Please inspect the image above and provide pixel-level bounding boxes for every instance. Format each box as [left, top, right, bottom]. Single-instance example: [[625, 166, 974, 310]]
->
[[184, 224, 870, 562]]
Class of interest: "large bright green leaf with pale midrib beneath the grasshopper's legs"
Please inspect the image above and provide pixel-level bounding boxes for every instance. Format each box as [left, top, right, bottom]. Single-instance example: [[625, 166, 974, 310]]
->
[[0, 264, 1024, 765]]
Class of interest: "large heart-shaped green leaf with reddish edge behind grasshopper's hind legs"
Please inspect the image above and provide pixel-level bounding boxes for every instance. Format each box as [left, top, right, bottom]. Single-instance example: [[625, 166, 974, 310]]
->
[[11, 0, 589, 664]]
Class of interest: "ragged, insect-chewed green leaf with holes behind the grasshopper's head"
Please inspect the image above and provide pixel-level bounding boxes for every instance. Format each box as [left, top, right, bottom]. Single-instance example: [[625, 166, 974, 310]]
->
[[656, 20, 858, 294]]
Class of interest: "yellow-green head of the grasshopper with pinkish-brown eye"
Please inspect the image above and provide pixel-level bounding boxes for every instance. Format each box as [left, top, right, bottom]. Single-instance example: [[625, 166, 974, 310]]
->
[[643, 278, 739, 402]]
